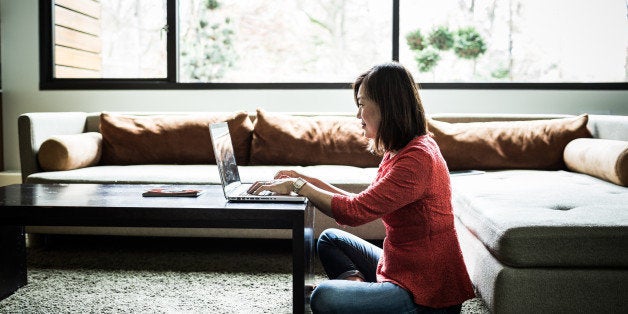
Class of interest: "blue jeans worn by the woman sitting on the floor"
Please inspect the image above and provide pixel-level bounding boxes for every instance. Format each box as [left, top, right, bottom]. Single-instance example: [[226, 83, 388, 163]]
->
[[310, 229, 461, 313]]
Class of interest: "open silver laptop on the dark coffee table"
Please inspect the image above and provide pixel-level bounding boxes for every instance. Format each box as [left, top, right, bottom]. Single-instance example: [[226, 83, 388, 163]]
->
[[209, 122, 307, 203]]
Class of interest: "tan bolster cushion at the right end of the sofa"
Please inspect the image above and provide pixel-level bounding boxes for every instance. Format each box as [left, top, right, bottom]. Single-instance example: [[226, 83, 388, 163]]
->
[[563, 138, 628, 186]]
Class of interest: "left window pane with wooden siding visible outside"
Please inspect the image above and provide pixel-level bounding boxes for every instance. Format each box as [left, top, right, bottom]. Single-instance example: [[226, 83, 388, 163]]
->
[[45, 0, 168, 79]]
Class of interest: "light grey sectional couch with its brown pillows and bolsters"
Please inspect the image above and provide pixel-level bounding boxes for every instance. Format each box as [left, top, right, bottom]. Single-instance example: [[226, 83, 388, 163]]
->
[[18, 110, 628, 313]]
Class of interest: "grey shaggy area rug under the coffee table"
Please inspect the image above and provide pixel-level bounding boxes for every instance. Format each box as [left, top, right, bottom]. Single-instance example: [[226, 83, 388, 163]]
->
[[0, 236, 488, 313]]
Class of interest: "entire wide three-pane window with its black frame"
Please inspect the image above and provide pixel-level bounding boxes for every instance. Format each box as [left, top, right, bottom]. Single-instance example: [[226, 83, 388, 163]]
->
[[40, 0, 628, 89]]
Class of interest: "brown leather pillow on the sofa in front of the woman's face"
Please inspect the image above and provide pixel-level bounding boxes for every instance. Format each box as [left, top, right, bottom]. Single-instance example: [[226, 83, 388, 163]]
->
[[251, 109, 381, 167]]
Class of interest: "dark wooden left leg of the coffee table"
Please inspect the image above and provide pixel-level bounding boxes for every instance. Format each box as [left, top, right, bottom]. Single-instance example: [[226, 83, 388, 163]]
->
[[0, 226, 26, 300]]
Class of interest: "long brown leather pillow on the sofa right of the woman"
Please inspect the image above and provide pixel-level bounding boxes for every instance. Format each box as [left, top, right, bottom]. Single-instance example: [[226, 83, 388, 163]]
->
[[428, 115, 591, 170]]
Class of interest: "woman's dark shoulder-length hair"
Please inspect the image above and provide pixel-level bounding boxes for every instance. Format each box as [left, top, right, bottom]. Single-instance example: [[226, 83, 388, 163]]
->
[[353, 62, 427, 155]]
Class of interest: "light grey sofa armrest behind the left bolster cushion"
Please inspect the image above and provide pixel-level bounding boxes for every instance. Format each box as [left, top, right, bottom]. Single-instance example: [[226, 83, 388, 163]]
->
[[18, 112, 87, 182]]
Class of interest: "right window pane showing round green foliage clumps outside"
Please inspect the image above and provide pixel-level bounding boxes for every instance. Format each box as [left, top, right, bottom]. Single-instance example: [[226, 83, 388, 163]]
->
[[399, 0, 628, 83]]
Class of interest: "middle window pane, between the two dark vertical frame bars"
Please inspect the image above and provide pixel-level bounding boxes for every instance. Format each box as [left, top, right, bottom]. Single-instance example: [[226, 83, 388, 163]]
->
[[179, 0, 392, 83]]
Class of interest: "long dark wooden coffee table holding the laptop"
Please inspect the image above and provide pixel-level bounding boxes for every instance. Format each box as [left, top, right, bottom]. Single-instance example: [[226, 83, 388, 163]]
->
[[0, 184, 315, 313]]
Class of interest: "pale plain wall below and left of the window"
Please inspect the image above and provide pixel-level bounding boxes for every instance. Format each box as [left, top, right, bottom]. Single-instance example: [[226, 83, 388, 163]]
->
[[0, 0, 628, 170]]
